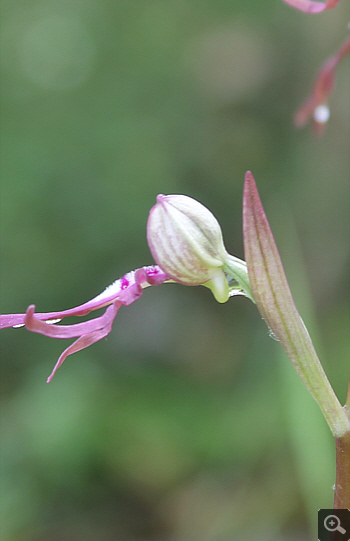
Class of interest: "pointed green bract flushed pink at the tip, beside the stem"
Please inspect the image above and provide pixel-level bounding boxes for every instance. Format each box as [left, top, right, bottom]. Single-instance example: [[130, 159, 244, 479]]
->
[[243, 172, 349, 436]]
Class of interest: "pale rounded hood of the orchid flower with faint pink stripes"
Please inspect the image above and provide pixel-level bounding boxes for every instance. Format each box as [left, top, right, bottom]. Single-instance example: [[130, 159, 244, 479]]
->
[[147, 194, 253, 302]]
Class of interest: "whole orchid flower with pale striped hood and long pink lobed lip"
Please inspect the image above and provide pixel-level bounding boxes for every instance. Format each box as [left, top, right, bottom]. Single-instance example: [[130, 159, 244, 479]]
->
[[0, 195, 253, 382]]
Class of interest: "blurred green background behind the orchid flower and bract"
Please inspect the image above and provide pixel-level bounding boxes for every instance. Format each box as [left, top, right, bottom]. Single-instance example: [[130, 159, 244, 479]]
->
[[0, 0, 350, 541]]
